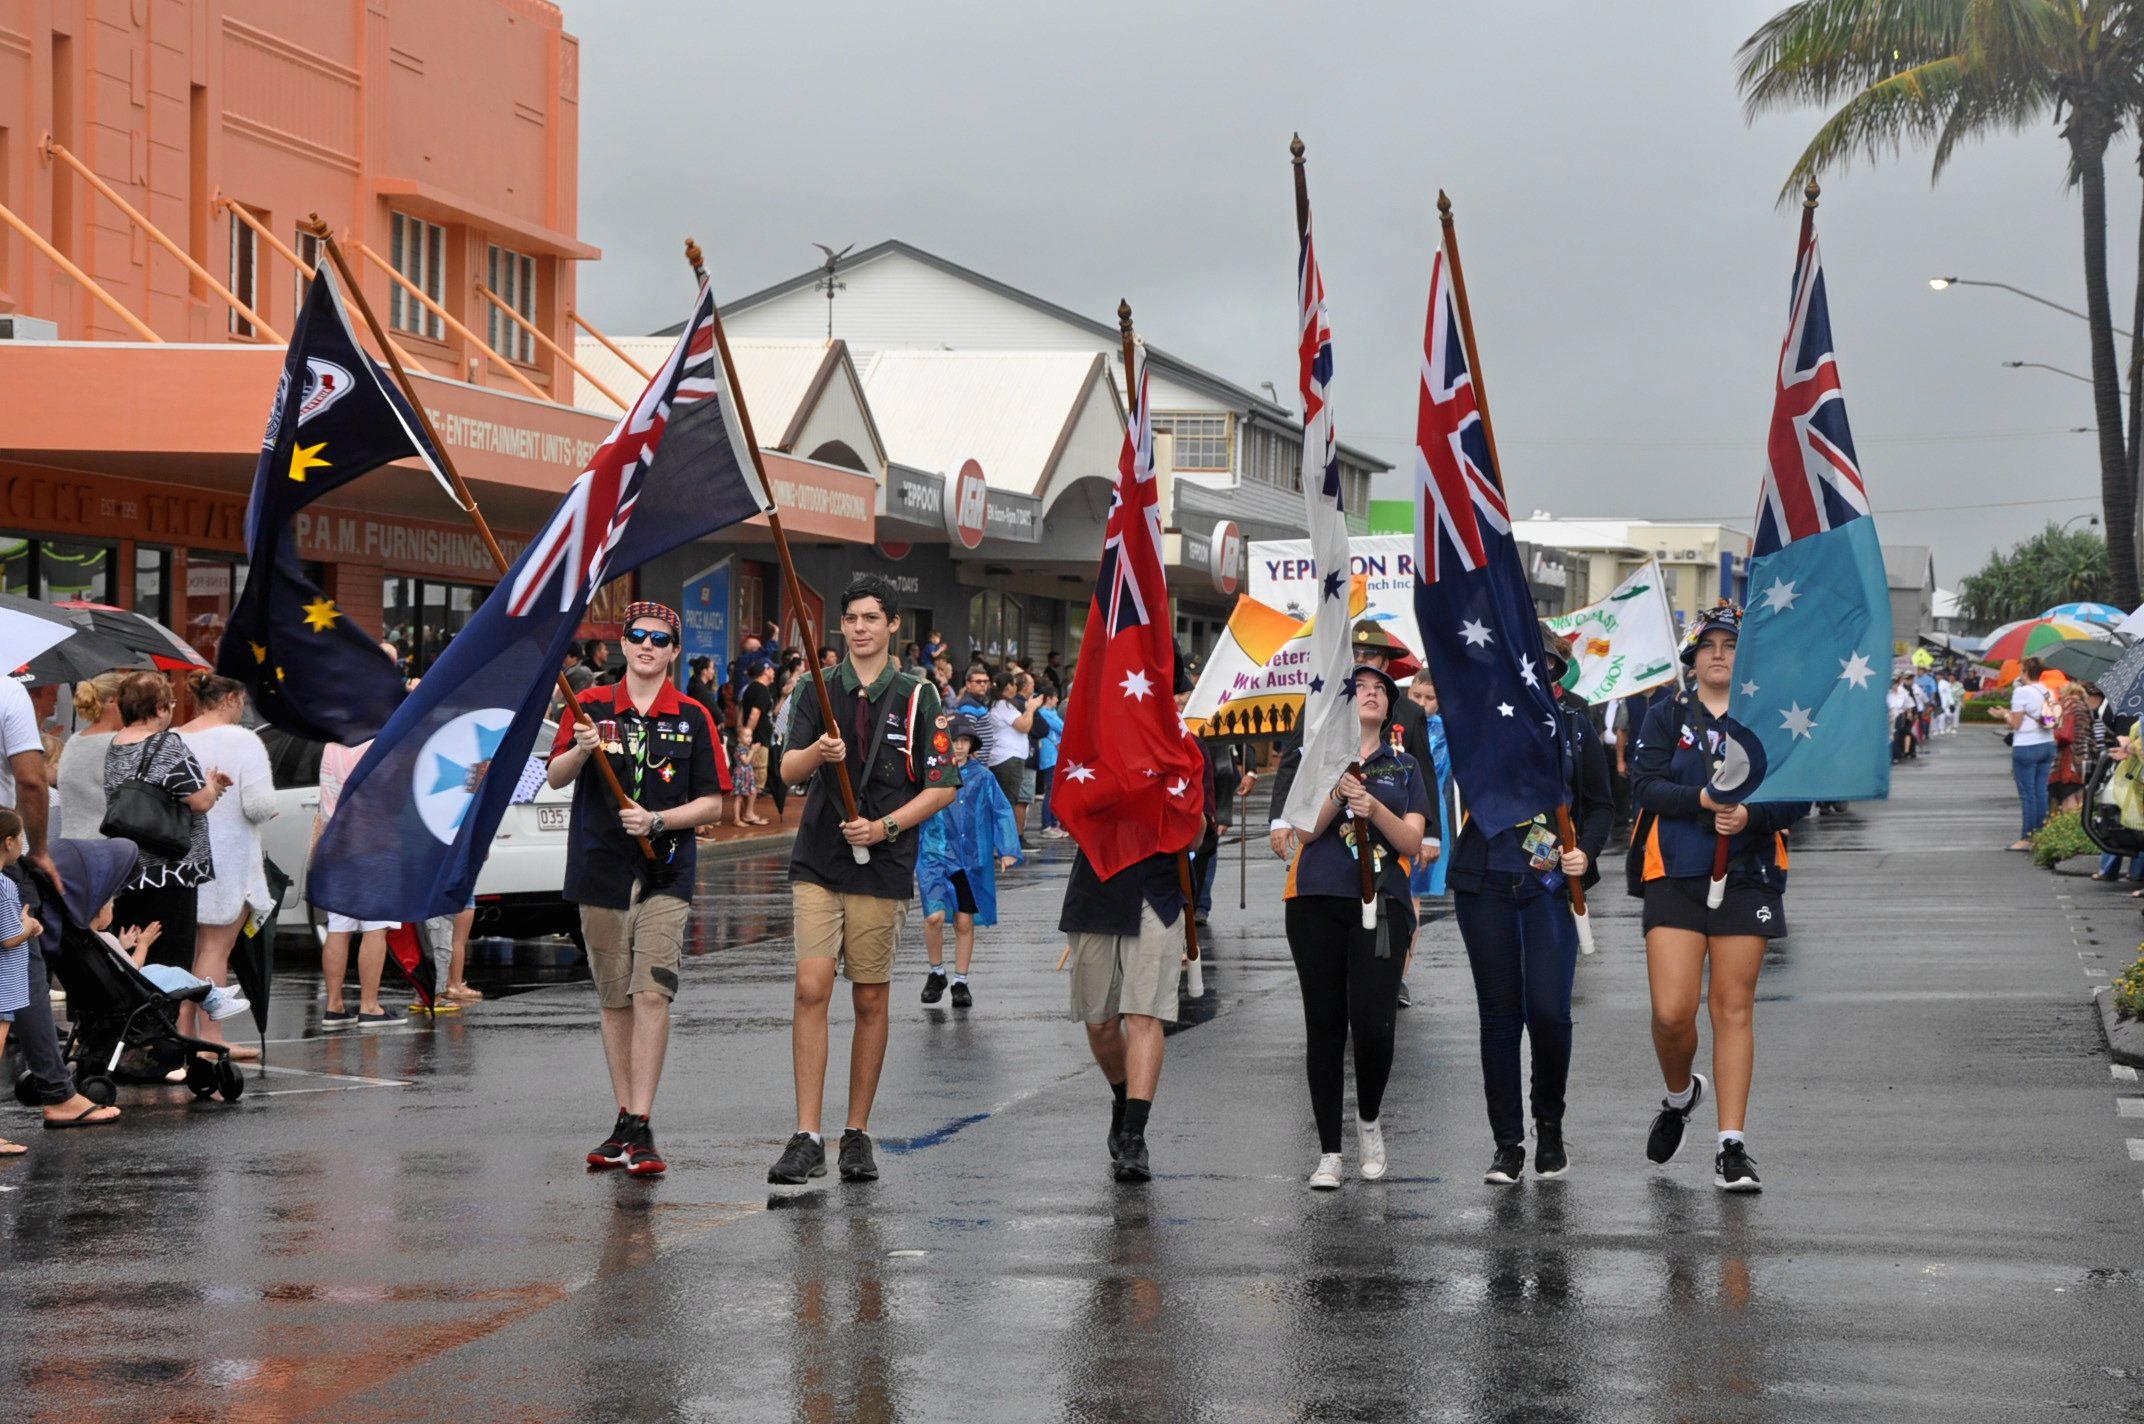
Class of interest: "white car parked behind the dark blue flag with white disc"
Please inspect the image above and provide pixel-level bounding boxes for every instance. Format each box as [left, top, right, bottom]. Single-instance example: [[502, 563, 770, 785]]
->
[[259, 721, 581, 939]]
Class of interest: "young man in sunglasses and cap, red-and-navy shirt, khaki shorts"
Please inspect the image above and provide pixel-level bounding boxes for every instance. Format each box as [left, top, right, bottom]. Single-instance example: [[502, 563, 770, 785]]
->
[[549, 603, 729, 1177]]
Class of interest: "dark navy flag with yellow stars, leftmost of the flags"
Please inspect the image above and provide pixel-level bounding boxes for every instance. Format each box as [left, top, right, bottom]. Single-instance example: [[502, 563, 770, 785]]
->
[[217, 266, 452, 746]]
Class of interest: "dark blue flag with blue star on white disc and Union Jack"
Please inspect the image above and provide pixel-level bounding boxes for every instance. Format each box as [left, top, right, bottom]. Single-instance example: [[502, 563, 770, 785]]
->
[[307, 285, 774, 920]]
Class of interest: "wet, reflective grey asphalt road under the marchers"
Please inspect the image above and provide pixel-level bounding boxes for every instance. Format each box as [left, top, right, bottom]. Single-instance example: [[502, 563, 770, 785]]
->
[[0, 731, 2144, 1422]]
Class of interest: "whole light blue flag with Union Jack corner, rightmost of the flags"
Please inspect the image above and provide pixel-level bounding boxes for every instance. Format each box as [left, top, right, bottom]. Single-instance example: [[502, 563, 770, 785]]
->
[[1728, 221, 1891, 802]]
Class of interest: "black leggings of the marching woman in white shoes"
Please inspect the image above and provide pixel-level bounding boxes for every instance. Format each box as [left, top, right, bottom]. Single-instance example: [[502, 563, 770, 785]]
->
[[1286, 894, 1415, 1152]]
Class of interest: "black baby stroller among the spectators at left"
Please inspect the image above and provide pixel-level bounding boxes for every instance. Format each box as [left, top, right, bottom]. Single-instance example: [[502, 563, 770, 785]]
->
[[15, 841, 247, 1104]]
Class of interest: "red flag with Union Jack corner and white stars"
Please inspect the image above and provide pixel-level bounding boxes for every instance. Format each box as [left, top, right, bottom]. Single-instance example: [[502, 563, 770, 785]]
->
[[1051, 345, 1207, 879]]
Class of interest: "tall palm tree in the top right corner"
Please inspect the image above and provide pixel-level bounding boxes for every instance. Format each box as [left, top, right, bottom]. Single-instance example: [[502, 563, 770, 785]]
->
[[1734, 0, 2144, 609]]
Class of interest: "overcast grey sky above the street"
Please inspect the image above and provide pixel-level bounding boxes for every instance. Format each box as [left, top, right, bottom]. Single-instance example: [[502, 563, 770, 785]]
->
[[564, 0, 2138, 585]]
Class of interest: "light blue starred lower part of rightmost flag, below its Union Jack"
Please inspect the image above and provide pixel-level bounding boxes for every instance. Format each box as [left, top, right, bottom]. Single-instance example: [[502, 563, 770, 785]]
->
[[1728, 503, 1891, 802]]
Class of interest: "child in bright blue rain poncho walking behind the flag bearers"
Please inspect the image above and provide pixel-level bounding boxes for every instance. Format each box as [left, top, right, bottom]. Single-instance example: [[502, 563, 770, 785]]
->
[[915, 714, 1021, 1008]]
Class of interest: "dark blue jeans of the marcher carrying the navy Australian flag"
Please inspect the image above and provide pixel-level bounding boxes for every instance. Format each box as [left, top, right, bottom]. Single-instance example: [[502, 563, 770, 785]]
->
[[1451, 871, 1578, 1147]]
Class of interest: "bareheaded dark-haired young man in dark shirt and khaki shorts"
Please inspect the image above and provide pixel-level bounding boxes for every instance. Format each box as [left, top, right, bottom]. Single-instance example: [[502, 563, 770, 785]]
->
[[768, 573, 961, 1186]]
